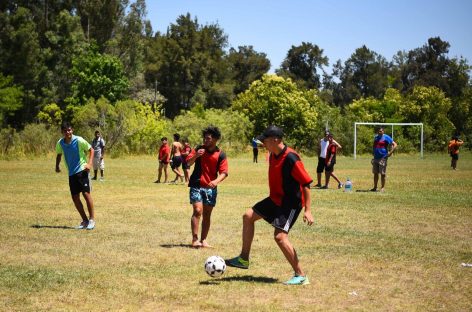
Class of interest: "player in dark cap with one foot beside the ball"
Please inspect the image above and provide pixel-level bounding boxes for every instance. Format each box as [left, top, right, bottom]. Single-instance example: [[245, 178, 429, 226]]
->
[[225, 126, 313, 285]]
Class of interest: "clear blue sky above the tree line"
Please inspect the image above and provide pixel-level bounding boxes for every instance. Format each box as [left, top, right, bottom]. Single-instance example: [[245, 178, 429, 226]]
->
[[146, 0, 472, 72]]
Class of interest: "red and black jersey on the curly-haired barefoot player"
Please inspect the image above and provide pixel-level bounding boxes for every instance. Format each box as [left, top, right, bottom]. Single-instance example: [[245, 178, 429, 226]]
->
[[186, 146, 228, 187]]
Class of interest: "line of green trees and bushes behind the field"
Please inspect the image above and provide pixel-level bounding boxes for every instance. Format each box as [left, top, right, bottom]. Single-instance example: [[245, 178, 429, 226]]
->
[[0, 0, 472, 154]]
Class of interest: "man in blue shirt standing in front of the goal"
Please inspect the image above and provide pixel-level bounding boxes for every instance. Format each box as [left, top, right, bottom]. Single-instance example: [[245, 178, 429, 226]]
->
[[371, 127, 397, 192]]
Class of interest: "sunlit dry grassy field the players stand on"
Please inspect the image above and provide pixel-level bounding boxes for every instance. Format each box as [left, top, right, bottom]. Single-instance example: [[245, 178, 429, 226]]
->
[[0, 153, 472, 311]]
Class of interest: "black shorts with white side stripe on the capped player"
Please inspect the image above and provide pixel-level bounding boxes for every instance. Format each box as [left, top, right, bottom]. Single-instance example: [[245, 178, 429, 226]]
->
[[252, 197, 302, 233]]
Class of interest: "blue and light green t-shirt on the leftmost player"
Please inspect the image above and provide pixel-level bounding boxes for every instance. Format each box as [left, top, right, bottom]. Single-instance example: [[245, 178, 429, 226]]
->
[[56, 135, 92, 176]]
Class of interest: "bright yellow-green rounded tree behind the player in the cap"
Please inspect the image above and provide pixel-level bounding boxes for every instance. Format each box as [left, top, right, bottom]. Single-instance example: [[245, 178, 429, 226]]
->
[[233, 75, 318, 147]]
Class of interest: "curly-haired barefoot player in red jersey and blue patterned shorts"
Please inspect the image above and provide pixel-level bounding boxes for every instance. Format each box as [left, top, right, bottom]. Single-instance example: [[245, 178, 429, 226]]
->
[[187, 126, 228, 248]]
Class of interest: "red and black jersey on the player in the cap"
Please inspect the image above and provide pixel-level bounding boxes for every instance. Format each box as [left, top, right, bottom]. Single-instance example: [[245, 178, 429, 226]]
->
[[269, 146, 313, 208]]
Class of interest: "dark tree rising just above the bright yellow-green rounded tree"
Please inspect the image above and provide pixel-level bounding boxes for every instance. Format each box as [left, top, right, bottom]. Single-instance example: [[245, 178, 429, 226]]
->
[[276, 42, 329, 89]]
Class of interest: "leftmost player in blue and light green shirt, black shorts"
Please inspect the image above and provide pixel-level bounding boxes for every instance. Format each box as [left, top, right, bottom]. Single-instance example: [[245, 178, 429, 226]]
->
[[56, 122, 95, 230]]
